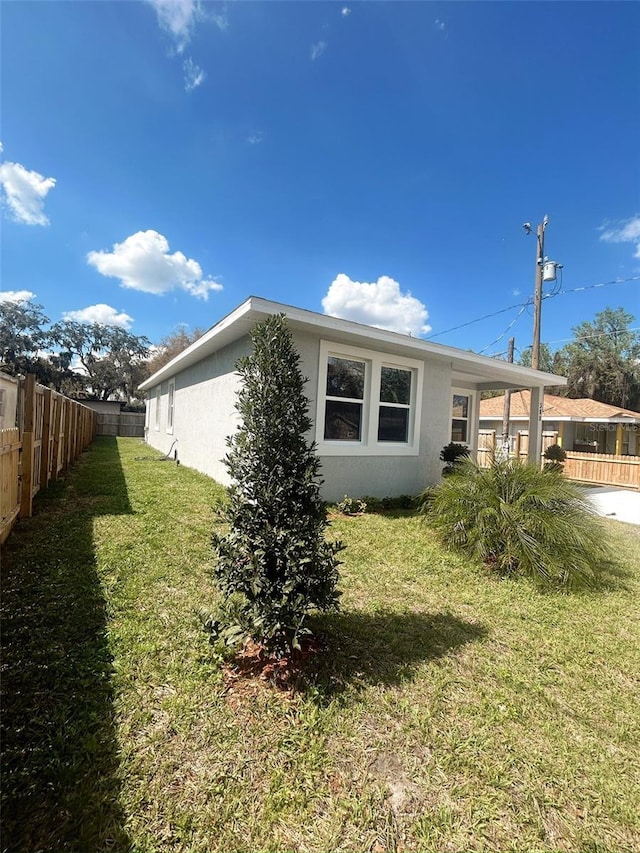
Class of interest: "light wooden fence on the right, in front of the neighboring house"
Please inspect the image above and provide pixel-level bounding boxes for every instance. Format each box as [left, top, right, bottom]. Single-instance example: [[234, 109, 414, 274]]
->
[[478, 429, 640, 489]]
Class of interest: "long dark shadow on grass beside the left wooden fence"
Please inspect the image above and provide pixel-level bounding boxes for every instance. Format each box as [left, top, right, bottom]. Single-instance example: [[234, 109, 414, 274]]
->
[[0, 437, 131, 853]]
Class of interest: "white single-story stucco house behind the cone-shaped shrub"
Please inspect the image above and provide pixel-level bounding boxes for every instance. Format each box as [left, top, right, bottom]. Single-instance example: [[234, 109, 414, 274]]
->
[[140, 296, 565, 500]]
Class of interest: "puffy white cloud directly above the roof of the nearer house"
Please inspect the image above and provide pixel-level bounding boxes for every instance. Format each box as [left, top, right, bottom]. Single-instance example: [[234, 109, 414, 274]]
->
[[322, 273, 431, 336]]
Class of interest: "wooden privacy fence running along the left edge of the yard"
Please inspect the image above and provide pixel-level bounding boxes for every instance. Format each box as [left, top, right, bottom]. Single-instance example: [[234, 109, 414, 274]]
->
[[0, 375, 96, 543]]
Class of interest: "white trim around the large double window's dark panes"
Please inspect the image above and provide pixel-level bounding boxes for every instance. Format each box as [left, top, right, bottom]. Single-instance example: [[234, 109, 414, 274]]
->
[[316, 340, 424, 456]]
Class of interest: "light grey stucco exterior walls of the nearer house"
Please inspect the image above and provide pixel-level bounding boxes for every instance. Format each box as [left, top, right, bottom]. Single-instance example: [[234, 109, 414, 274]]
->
[[147, 331, 451, 500]]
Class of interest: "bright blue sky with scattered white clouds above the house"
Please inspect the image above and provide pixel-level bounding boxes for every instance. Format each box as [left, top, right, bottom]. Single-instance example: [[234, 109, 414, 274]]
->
[[0, 0, 640, 354]]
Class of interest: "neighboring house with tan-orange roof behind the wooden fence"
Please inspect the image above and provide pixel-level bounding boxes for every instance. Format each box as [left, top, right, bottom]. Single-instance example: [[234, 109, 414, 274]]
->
[[479, 391, 640, 456]]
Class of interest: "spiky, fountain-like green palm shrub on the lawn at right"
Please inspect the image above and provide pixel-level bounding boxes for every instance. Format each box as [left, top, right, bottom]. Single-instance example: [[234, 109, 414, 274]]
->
[[421, 460, 610, 587]]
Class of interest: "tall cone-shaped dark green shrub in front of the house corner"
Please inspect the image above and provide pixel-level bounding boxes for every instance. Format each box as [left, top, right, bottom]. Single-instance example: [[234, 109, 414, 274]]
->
[[209, 315, 343, 655]]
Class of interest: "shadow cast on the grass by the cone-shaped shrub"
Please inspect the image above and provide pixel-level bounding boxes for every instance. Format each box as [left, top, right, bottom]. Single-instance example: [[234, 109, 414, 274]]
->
[[306, 611, 488, 699]]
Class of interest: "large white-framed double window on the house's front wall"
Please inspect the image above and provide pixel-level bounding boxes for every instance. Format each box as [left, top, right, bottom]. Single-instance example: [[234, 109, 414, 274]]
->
[[316, 341, 423, 455]]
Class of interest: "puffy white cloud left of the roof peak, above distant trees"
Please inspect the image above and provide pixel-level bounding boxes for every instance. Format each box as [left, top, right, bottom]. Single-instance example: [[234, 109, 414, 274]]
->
[[87, 230, 222, 299]]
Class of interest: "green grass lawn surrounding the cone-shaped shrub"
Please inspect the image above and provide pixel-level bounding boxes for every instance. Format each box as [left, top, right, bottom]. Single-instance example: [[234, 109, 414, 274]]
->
[[0, 438, 640, 853]]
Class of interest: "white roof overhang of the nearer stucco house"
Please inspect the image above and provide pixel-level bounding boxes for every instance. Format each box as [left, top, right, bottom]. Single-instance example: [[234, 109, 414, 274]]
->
[[140, 296, 567, 391]]
